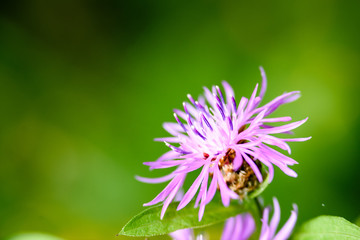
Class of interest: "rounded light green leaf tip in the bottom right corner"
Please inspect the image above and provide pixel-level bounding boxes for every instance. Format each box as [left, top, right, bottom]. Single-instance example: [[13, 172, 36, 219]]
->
[[294, 216, 360, 240]]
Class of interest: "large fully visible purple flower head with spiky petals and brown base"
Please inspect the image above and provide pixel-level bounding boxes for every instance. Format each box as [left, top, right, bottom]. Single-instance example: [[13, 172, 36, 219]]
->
[[137, 68, 310, 221]]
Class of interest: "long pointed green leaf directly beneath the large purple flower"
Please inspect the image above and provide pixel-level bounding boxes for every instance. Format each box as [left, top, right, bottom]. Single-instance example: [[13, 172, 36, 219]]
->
[[119, 201, 251, 237]]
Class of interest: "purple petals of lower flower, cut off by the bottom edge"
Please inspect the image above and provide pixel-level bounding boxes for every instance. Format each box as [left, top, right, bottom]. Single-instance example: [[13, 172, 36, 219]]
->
[[221, 198, 297, 240]]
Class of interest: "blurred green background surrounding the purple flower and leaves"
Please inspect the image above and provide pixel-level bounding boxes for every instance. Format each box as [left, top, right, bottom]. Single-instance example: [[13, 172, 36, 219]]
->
[[0, 0, 360, 239]]
